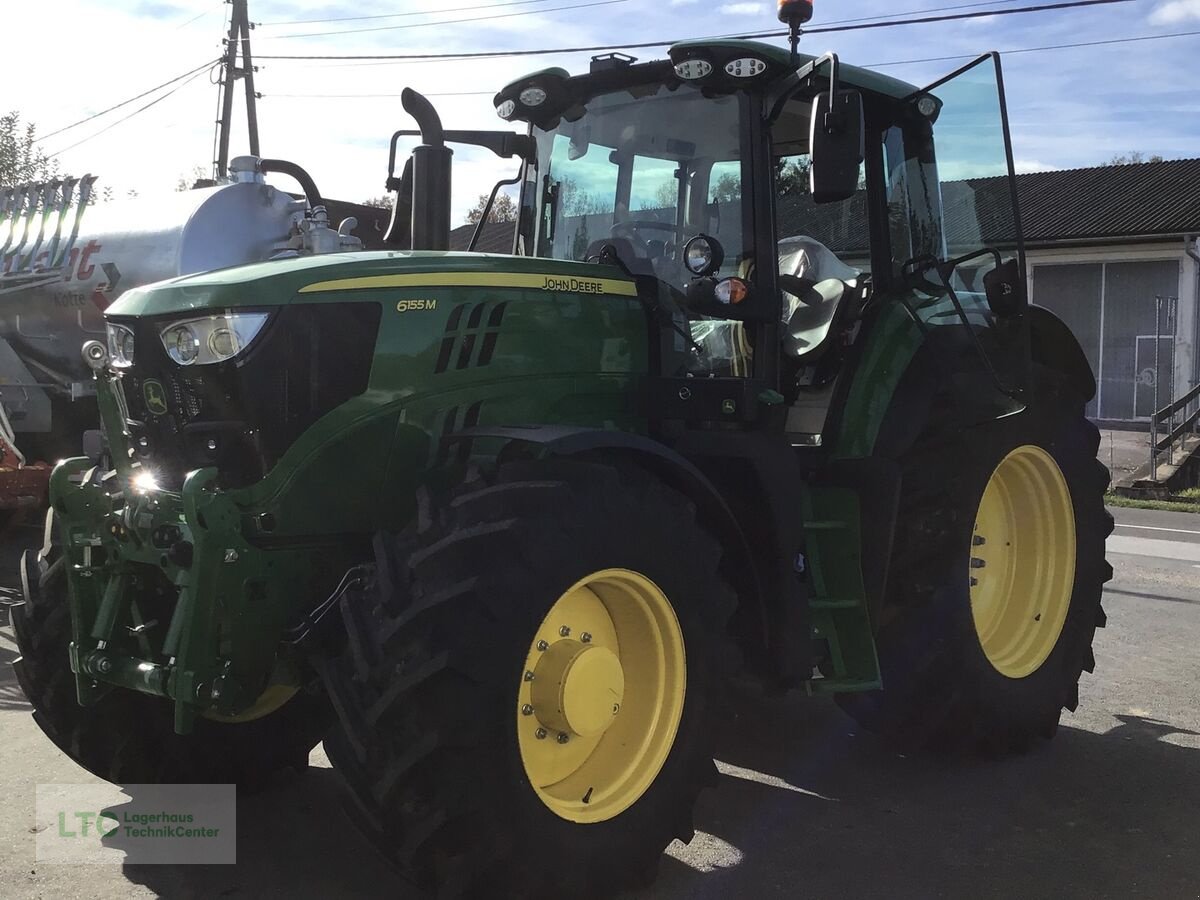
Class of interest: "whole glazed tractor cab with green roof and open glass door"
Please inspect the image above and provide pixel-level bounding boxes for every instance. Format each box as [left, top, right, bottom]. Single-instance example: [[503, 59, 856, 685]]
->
[[496, 41, 1026, 444]]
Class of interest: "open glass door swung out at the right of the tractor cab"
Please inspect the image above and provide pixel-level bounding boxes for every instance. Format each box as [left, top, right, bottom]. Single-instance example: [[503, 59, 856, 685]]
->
[[884, 53, 1030, 415]]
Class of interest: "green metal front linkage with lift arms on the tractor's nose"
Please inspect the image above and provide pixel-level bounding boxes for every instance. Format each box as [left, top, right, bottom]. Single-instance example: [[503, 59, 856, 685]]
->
[[43, 342, 301, 734]]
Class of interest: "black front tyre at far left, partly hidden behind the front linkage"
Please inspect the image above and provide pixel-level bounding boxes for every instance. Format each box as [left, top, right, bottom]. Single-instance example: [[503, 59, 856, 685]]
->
[[12, 511, 334, 790]]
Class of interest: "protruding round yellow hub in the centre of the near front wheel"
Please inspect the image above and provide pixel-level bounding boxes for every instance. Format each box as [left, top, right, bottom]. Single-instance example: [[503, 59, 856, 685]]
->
[[532, 641, 625, 738]]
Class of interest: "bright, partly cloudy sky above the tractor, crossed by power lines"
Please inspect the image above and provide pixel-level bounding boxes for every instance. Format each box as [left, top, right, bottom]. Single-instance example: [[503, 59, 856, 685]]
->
[[0, 0, 1200, 223]]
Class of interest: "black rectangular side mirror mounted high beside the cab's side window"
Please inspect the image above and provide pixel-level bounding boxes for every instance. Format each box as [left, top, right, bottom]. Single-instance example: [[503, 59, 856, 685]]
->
[[809, 90, 864, 203]]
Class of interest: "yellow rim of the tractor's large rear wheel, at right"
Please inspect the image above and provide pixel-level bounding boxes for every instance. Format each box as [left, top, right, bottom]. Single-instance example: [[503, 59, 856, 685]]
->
[[970, 445, 1075, 678]]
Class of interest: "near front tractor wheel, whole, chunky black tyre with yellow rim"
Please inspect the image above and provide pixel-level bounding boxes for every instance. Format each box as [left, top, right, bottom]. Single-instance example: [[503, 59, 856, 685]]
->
[[326, 461, 734, 896]]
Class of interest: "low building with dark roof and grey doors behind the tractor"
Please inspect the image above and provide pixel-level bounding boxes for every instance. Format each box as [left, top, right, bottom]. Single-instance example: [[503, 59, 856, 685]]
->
[[451, 160, 1200, 424]]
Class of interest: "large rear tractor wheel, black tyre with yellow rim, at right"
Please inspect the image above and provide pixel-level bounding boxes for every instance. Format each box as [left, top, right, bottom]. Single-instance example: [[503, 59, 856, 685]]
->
[[839, 367, 1112, 754]]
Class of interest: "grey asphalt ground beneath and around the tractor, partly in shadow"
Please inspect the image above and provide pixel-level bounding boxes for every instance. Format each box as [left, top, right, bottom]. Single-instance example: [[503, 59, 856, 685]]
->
[[0, 510, 1200, 900]]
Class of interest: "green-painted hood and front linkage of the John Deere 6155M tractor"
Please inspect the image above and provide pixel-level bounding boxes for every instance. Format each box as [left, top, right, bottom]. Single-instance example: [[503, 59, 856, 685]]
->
[[50, 252, 649, 732]]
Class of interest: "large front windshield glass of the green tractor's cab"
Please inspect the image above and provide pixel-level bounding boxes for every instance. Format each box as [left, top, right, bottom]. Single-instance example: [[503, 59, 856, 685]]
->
[[522, 84, 751, 290]]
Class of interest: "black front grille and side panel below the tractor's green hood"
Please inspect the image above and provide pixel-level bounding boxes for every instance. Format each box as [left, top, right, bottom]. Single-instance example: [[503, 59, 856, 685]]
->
[[114, 302, 380, 490]]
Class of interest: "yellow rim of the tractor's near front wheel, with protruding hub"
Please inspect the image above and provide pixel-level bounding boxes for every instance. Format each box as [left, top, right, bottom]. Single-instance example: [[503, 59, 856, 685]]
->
[[516, 569, 688, 822]]
